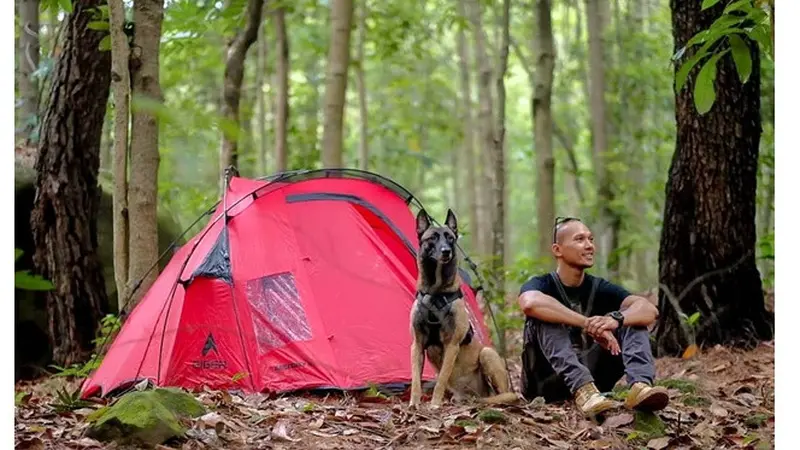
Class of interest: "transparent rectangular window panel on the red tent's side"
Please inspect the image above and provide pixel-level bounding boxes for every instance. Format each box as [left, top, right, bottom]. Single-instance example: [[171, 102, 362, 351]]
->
[[246, 272, 311, 354]]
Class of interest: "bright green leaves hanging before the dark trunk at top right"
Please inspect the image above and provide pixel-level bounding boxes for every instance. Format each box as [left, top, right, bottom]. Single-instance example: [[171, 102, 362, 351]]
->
[[673, 0, 773, 115]]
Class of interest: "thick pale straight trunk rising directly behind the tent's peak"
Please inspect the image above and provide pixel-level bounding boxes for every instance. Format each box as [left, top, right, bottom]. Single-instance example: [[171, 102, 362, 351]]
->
[[322, 0, 353, 168]]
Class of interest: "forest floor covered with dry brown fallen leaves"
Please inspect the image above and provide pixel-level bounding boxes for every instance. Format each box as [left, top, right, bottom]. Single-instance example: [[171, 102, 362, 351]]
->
[[15, 342, 775, 450]]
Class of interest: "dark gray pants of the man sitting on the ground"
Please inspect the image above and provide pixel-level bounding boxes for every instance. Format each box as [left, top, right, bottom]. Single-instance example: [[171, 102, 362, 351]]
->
[[522, 319, 655, 402]]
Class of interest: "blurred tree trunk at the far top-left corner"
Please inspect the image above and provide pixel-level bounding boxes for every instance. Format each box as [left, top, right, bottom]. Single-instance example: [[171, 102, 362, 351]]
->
[[17, 0, 39, 145]]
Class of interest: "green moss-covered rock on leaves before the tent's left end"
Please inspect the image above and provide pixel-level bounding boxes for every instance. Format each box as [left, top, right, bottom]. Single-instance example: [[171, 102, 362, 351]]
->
[[86, 388, 206, 446]]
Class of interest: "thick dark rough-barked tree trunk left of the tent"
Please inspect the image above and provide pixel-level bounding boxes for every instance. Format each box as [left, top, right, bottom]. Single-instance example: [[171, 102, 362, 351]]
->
[[31, 0, 111, 366]]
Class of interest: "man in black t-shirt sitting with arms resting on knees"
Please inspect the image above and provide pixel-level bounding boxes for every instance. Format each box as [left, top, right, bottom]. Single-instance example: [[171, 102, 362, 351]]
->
[[519, 218, 669, 417]]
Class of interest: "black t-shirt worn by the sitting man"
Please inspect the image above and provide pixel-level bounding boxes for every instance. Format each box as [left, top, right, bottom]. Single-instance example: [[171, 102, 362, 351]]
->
[[519, 273, 631, 317]]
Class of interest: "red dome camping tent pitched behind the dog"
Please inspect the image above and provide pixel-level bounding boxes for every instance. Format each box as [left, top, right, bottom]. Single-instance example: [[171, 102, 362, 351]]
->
[[82, 169, 490, 397]]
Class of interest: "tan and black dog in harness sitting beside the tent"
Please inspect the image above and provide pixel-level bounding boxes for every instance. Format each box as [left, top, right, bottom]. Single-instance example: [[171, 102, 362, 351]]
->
[[409, 209, 519, 409]]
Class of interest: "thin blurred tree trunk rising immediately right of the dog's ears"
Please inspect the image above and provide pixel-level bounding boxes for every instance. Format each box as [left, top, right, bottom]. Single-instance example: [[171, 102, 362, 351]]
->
[[456, 0, 483, 253]]
